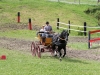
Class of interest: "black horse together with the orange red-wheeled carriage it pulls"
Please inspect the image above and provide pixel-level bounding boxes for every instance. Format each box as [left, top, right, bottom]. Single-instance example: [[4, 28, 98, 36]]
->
[[31, 30, 69, 58]]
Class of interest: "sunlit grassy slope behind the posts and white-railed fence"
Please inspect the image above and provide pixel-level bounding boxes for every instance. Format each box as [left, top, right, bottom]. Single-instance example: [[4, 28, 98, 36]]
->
[[0, 0, 97, 27]]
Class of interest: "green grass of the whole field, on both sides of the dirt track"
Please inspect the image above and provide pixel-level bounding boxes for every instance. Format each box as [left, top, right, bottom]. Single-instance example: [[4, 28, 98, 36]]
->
[[0, 0, 100, 75]]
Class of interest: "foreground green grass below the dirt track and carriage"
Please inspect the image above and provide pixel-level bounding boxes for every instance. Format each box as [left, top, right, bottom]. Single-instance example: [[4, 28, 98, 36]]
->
[[0, 48, 100, 75]]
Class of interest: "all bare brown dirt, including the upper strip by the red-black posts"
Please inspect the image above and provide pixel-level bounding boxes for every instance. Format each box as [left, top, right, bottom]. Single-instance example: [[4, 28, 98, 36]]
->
[[0, 23, 100, 61]]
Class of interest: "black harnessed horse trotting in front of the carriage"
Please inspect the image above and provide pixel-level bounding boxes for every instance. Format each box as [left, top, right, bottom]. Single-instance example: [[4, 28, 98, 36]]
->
[[52, 30, 69, 60]]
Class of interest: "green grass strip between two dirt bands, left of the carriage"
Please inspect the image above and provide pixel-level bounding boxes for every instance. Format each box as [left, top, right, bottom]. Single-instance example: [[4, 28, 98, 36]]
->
[[0, 30, 37, 40]]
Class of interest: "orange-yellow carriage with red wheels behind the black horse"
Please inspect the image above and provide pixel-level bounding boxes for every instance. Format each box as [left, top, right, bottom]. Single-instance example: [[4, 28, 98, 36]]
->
[[31, 32, 53, 58]]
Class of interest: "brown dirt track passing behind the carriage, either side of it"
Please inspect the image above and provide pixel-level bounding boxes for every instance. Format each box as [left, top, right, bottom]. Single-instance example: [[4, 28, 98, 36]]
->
[[0, 37, 100, 61]]
